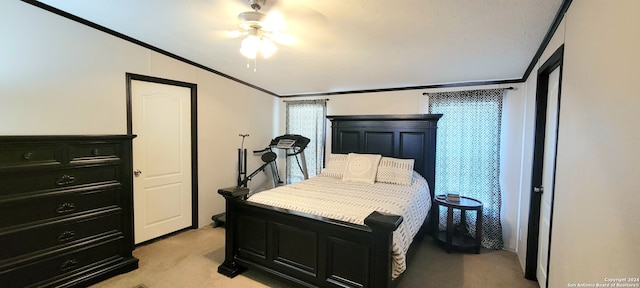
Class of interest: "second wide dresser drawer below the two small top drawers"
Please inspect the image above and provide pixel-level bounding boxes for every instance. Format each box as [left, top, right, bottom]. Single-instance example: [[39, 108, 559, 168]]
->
[[0, 184, 122, 230]]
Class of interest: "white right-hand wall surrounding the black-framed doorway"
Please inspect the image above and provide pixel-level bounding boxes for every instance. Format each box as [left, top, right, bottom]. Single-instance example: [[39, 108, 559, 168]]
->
[[518, 0, 640, 287]]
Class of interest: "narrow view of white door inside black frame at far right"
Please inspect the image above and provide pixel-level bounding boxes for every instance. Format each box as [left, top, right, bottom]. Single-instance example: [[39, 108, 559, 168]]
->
[[536, 68, 560, 288]]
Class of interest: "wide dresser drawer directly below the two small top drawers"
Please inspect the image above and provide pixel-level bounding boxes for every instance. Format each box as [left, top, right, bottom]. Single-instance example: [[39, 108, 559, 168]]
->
[[0, 165, 119, 196]]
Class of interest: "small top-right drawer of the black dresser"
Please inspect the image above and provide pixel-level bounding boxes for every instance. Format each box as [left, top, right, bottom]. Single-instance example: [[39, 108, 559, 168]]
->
[[69, 142, 122, 163]]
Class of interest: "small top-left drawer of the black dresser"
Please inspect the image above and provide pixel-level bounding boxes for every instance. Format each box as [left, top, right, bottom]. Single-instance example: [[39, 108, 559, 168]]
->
[[0, 143, 63, 171]]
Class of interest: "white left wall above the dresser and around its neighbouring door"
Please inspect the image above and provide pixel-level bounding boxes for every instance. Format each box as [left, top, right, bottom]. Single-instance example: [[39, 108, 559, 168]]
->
[[0, 1, 277, 226]]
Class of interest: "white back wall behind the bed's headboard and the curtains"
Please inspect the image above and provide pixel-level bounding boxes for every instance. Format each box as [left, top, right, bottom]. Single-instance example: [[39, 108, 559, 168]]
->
[[278, 84, 524, 251]]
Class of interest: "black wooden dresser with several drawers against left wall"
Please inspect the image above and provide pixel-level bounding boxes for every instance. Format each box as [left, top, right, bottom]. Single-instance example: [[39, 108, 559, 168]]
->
[[0, 135, 138, 287]]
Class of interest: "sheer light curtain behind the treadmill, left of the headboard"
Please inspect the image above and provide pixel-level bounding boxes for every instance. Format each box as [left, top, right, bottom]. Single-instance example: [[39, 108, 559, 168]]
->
[[286, 99, 327, 183]]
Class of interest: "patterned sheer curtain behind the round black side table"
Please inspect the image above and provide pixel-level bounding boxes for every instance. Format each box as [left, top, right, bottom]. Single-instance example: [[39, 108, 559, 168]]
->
[[428, 89, 504, 249]]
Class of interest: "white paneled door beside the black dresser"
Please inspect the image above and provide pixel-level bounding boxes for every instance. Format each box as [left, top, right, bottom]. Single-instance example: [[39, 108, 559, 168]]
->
[[131, 80, 192, 244]]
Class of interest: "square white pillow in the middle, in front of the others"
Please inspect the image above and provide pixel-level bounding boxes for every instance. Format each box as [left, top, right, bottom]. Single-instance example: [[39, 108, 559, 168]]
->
[[342, 153, 382, 184]]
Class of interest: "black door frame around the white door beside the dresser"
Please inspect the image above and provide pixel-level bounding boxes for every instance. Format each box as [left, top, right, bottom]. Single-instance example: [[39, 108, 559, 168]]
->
[[126, 73, 198, 229]]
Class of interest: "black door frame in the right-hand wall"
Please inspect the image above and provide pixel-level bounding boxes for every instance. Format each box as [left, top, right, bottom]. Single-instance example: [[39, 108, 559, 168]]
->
[[524, 45, 564, 287]]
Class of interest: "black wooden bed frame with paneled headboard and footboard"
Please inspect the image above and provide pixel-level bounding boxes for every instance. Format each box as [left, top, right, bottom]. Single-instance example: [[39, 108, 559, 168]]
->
[[218, 114, 442, 287]]
